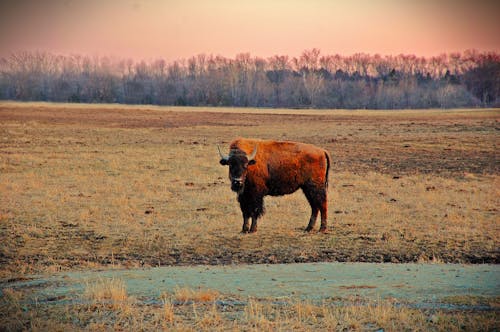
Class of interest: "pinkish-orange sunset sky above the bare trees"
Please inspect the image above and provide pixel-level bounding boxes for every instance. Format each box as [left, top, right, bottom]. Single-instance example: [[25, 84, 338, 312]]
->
[[0, 0, 500, 61]]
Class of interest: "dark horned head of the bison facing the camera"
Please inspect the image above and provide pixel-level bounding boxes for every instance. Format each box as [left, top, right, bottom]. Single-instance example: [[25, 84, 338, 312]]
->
[[217, 145, 257, 194]]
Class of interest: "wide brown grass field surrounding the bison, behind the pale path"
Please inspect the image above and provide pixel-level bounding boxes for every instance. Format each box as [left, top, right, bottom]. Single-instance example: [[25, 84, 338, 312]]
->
[[0, 103, 500, 278]]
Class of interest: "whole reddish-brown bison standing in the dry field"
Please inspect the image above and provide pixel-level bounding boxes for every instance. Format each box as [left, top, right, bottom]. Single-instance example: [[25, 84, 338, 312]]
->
[[217, 138, 330, 233]]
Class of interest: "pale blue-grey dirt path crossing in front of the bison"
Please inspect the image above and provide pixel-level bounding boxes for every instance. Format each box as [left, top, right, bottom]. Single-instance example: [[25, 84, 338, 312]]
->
[[4, 263, 500, 310]]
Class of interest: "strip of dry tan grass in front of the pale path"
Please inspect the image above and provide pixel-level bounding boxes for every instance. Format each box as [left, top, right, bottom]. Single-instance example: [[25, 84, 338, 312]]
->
[[0, 280, 500, 331]]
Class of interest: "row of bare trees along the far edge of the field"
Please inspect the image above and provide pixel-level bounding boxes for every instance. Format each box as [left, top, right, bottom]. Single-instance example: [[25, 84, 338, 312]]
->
[[0, 49, 500, 109]]
